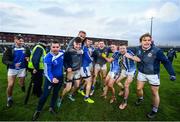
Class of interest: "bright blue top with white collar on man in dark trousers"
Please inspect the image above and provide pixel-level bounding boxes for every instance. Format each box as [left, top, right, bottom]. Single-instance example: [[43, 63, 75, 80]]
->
[[44, 51, 64, 82]]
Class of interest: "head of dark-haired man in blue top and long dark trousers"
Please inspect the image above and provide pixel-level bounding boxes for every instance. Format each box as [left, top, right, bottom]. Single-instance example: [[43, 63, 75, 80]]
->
[[51, 40, 61, 55]]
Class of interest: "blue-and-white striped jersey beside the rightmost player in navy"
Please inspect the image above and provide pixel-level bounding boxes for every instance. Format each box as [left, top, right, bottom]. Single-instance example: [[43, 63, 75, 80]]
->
[[122, 50, 136, 72]]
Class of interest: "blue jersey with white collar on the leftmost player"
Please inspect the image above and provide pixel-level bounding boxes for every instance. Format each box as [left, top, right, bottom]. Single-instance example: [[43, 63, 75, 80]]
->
[[9, 46, 26, 69]]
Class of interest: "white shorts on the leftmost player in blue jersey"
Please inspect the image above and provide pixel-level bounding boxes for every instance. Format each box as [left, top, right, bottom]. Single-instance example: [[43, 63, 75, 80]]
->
[[8, 68, 26, 77]]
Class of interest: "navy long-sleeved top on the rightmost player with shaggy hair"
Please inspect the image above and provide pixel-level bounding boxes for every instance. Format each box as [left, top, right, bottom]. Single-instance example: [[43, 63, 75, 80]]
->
[[133, 46, 175, 75]]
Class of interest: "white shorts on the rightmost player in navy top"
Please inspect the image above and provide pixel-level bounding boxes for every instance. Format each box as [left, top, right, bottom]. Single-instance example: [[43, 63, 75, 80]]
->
[[137, 72, 160, 86]]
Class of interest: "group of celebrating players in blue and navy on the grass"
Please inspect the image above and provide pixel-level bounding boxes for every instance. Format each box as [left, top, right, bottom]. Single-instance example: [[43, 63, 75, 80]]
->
[[3, 31, 176, 120]]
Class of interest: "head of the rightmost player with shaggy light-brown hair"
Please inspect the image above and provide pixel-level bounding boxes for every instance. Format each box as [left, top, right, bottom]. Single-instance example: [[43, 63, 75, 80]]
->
[[139, 33, 152, 50]]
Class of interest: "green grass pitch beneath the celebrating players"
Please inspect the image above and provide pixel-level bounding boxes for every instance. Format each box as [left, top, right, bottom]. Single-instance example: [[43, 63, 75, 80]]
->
[[0, 53, 180, 121]]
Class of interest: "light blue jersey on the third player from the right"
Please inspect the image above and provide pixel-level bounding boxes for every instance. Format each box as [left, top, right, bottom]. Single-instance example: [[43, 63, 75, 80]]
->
[[110, 51, 121, 72]]
